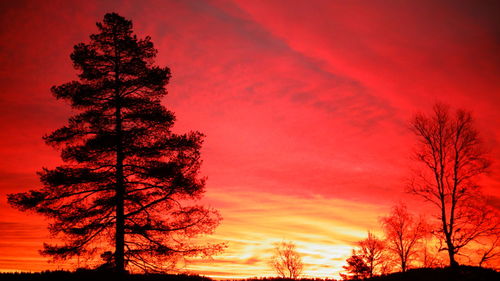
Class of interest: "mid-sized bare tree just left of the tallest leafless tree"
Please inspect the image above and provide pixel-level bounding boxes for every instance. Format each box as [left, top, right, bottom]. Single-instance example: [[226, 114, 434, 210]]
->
[[381, 203, 427, 272]]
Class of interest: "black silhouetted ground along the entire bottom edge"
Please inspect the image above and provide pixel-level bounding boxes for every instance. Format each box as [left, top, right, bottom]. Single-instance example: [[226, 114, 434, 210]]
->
[[0, 266, 500, 281]]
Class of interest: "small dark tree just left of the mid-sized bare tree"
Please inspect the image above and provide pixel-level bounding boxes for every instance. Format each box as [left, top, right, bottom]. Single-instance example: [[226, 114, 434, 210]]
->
[[358, 231, 385, 277]]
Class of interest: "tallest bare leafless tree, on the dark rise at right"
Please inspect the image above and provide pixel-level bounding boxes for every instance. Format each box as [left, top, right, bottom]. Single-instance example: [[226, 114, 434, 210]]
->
[[409, 104, 494, 267]]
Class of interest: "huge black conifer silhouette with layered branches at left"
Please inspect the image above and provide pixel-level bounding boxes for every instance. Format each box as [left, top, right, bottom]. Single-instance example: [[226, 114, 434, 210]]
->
[[9, 13, 221, 272]]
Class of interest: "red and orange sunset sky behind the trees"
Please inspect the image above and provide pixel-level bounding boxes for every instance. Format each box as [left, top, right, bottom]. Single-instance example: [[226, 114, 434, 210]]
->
[[0, 0, 500, 277]]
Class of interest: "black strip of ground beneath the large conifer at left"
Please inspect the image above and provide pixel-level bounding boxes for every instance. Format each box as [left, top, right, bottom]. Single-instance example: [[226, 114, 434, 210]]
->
[[0, 271, 213, 281]]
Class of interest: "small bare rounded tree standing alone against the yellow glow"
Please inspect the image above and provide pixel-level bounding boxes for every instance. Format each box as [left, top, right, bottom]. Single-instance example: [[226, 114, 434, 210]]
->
[[271, 241, 304, 278]]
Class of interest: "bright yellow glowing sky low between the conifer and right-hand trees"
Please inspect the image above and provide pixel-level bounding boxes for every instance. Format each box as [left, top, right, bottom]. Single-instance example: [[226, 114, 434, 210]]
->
[[186, 192, 381, 278]]
